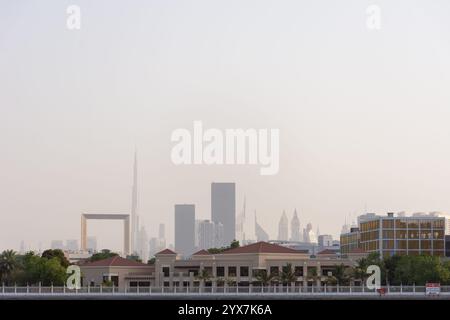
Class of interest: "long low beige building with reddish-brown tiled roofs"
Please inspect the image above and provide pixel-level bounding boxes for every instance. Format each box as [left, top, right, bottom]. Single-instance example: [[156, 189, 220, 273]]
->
[[81, 242, 366, 288]]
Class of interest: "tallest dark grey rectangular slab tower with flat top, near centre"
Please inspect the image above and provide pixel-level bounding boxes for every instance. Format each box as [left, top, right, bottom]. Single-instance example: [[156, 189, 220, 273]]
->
[[211, 182, 236, 245]]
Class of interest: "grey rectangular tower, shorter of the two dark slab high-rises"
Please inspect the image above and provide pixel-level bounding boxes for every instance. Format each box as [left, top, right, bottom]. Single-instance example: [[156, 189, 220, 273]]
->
[[175, 204, 195, 256]]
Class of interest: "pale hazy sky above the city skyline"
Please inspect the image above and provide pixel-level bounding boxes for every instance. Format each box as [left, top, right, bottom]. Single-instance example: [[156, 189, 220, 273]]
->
[[0, 0, 450, 249]]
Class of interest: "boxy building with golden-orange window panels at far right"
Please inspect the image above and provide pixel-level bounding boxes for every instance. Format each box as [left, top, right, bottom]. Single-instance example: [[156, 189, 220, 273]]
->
[[341, 213, 445, 257]]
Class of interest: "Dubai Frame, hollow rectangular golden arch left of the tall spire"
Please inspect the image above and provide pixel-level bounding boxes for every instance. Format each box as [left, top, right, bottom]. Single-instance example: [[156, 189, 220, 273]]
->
[[81, 213, 131, 255]]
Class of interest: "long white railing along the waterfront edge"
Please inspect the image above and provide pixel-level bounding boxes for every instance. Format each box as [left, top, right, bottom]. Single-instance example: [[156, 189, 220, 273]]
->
[[0, 285, 450, 297]]
